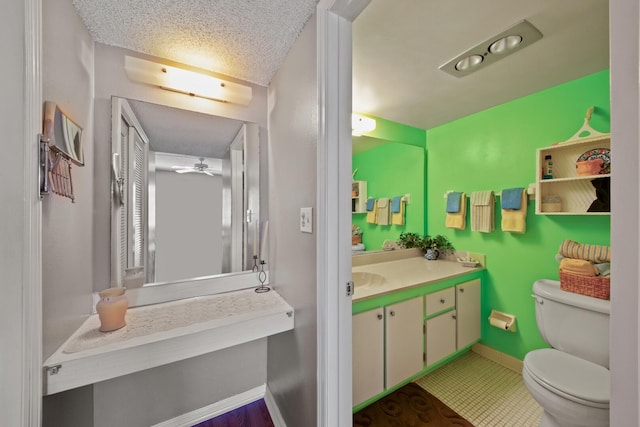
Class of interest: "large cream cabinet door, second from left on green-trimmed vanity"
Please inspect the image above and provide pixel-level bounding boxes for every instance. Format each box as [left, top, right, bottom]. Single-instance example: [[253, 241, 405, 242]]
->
[[385, 297, 424, 388]]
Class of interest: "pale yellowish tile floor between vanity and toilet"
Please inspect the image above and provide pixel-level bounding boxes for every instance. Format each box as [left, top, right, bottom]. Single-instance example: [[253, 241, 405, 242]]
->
[[415, 351, 542, 427]]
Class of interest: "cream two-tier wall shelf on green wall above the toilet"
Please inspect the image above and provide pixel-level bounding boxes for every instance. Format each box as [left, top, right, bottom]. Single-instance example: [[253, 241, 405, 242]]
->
[[535, 134, 611, 215]]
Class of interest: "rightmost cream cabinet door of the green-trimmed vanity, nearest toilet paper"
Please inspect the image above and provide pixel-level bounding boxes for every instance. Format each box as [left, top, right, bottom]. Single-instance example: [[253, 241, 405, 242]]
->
[[456, 279, 480, 350]]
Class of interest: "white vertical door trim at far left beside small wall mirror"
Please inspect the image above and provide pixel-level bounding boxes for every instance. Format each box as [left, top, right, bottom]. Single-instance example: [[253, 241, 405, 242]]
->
[[23, 0, 43, 427]]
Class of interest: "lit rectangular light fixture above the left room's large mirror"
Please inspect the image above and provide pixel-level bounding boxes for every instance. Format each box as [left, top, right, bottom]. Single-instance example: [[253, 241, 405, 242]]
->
[[124, 56, 252, 105]]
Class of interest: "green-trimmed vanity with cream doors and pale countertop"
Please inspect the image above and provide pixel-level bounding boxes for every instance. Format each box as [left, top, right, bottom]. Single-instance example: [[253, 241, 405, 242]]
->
[[352, 251, 485, 411]]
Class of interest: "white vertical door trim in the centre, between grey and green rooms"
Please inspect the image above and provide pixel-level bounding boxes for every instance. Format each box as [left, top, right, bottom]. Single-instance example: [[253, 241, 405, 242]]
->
[[316, 0, 368, 427]]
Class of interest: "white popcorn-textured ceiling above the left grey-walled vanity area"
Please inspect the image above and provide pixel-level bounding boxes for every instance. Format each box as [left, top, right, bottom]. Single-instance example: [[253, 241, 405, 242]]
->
[[73, 0, 316, 86]]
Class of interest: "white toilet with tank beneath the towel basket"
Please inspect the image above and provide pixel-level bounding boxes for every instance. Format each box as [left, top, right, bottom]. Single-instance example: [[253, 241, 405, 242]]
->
[[522, 280, 611, 427]]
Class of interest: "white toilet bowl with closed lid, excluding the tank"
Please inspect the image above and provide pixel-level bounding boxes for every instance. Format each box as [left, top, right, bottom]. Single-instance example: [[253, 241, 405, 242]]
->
[[522, 349, 610, 427]]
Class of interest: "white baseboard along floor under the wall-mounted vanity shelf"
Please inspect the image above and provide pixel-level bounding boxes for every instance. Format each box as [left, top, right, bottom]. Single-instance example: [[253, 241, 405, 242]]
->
[[152, 384, 264, 427]]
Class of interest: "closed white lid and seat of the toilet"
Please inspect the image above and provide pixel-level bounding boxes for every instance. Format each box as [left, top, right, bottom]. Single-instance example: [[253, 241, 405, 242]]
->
[[524, 348, 611, 407]]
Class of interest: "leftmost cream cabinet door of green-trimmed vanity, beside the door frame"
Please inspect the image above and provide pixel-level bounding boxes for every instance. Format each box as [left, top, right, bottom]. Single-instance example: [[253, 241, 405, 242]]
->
[[352, 308, 384, 406]]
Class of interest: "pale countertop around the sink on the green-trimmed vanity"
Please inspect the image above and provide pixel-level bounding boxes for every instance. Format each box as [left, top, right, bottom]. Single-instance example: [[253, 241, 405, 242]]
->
[[352, 256, 484, 302]]
